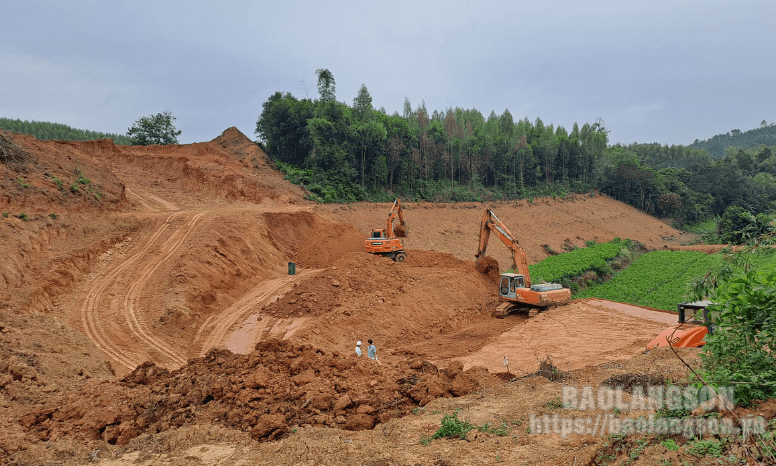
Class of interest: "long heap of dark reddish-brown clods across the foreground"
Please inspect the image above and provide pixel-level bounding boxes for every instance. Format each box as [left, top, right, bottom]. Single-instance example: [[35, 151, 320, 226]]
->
[[21, 340, 500, 445]]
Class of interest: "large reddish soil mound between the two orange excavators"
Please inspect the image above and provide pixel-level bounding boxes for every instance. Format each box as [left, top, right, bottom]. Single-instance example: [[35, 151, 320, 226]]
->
[[261, 251, 493, 358]]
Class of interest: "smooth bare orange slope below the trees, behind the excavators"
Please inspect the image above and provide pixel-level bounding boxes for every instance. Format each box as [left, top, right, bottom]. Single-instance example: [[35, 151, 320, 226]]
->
[[315, 194, 696, 271]]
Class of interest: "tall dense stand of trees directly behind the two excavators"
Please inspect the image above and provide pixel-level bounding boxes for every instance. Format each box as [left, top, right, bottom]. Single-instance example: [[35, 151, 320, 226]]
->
[[256, 70, 608, 202]]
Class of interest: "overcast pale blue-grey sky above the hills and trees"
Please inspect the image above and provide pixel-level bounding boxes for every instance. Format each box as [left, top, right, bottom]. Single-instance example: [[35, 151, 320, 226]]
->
[[0, 0, 776, 144]]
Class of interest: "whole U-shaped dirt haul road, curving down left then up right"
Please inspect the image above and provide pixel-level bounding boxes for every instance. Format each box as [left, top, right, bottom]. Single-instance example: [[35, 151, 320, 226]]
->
[[76, 195, 314, 373]]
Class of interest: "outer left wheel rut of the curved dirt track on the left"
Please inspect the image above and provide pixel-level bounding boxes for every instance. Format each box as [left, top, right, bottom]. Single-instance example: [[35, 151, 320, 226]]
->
[[81, 212, 182, 371]]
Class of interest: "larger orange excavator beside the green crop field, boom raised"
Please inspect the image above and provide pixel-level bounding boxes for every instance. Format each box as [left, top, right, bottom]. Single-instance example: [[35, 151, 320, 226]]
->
[[475, 209, 571, 319]]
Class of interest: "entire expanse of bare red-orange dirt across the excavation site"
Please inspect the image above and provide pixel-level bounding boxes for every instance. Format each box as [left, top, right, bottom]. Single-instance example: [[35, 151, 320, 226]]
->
[[0, 128, 764, 465]]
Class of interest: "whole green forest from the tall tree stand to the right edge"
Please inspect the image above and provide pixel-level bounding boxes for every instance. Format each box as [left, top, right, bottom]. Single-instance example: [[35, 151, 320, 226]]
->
[[256, 70, 776, 228]]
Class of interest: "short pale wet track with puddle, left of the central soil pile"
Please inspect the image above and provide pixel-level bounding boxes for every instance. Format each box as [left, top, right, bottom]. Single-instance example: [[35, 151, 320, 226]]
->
[[192, 270, 320, 357]]
